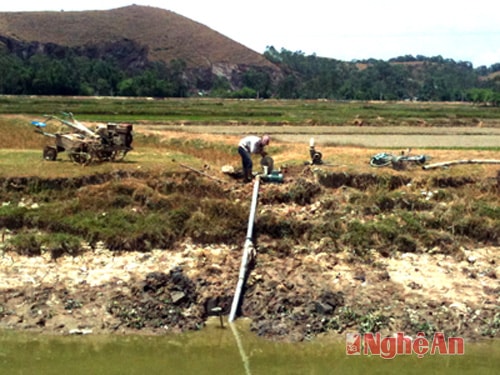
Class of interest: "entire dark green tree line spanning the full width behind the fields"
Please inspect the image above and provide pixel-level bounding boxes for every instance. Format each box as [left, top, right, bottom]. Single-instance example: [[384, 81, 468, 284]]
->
[[0, 47, 500, 105]]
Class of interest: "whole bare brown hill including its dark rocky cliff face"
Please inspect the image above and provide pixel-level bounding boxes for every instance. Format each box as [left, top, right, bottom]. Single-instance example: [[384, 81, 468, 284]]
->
[[0, 5, 281, 87]]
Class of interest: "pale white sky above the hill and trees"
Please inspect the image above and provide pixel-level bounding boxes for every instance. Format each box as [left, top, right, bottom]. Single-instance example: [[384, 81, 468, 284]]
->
[[0, 0, 500, 68]]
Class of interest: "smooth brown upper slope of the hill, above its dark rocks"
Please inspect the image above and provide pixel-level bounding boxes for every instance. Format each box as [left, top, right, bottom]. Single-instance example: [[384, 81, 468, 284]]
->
[[0, 5, 277, 70]]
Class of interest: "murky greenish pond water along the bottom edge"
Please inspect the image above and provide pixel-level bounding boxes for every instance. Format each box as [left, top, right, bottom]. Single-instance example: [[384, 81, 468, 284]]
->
[[0, 320, 500, 375]]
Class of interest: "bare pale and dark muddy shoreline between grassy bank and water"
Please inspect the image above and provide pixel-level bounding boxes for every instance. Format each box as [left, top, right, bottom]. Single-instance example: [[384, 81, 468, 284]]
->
[[0, 243, 500, 341]]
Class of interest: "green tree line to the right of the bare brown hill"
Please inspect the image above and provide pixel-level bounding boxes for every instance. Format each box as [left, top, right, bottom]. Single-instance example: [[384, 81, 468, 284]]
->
[[264, 47, 500, 105]]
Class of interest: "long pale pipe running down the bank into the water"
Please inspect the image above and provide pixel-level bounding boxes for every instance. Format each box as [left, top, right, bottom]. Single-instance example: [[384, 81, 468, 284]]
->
[[229, 176, 260, 322]]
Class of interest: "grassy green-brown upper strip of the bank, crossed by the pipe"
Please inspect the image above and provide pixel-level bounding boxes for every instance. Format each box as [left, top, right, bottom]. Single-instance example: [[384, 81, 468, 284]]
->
[[0, 167, 500, 261]]
